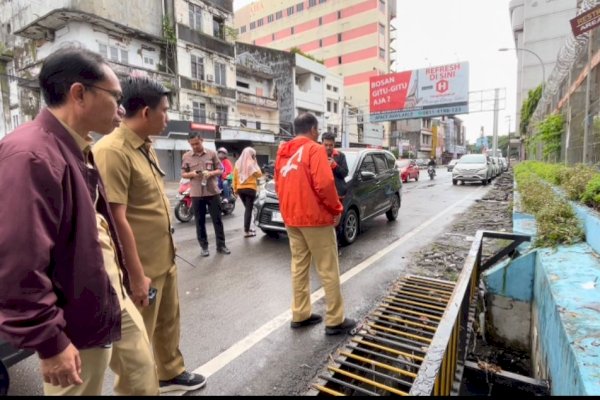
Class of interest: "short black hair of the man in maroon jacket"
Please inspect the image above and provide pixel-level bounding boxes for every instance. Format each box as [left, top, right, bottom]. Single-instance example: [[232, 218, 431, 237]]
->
[[38, 44, 108, 107]]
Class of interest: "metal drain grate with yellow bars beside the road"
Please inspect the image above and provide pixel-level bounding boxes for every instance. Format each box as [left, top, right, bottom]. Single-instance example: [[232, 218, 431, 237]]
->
[[312, 275, 455, 396]]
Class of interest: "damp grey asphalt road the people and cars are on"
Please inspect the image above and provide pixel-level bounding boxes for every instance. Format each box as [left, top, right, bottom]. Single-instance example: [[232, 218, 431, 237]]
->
[[9, 168, 487, 395]]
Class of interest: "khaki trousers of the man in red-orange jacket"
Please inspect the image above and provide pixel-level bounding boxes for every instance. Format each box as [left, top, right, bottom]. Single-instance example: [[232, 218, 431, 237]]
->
[[286, 226, 344, 326]]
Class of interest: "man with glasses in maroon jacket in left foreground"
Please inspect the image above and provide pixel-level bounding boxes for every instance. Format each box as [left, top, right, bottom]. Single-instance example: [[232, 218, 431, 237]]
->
[[0, 46, 158, 396]]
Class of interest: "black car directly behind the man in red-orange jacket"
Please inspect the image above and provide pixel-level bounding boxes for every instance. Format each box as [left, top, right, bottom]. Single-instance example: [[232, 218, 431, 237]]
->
[[254, 148, 402, 245]]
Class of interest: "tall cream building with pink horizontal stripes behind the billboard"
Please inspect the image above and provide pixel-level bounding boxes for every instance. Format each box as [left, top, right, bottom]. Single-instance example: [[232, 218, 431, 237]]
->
[[234, 0, 396, 145]]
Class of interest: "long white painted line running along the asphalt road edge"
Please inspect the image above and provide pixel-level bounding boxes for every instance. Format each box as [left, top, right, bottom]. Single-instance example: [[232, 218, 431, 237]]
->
[[177, 187, 483, 395]]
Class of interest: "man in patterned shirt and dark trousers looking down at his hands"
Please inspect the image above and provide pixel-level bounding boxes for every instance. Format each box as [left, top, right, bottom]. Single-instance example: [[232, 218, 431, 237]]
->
[[181, 134, 231, 257]]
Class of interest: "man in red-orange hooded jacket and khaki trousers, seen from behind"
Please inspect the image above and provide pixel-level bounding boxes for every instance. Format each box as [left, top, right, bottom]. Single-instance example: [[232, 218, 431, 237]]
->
[[275, 113, 356, 335]]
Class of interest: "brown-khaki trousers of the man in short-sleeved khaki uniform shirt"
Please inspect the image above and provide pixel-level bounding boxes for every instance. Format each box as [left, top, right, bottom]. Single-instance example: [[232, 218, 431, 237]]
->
[[139, 265, 185, 381]]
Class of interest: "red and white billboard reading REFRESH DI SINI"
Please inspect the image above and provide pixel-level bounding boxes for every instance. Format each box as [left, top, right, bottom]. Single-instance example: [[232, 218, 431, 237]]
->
[[369, 62, 469, 122]]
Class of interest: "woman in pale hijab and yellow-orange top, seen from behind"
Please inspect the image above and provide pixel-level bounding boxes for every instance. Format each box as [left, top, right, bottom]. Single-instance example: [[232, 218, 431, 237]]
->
[[233, 147, 262, 237]]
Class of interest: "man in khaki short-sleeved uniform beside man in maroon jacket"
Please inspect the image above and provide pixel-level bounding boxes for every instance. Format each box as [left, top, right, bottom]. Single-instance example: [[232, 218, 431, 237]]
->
[[93, 77, 206, 392]]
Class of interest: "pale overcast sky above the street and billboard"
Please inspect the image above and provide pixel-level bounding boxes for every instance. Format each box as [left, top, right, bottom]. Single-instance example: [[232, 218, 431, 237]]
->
[[233, 0, 517, 143]]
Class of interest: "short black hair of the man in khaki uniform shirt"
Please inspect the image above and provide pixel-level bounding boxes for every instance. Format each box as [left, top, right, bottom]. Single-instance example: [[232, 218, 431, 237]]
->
[[121, 76, 170, 118]]
